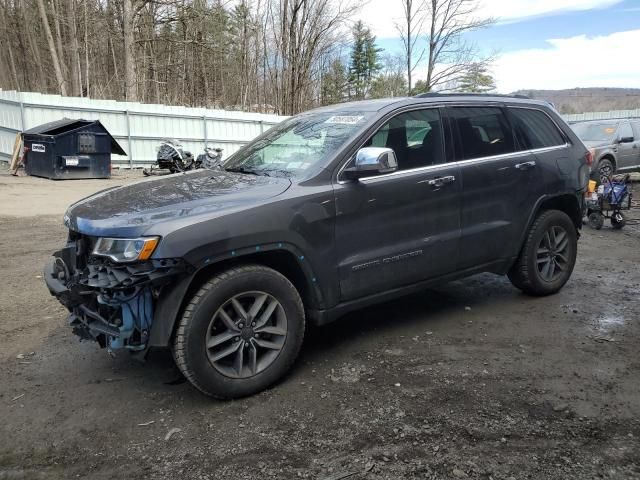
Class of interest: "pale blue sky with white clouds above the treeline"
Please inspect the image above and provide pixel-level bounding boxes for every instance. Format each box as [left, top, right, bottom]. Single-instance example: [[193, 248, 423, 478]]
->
[[359, 0, 640, 93]]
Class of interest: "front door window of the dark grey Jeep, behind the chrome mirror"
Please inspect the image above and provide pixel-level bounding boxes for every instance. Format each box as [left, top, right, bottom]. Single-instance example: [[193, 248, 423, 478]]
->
[[363, 108, 444, 170]]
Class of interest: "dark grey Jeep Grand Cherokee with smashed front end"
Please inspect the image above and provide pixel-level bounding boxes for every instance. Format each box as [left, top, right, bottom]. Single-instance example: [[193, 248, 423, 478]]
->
[[45, 95, 590, 398]]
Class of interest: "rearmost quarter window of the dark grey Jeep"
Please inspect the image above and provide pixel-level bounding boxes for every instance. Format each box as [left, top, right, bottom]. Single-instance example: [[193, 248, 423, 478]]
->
[[509, 107, 566, 150]]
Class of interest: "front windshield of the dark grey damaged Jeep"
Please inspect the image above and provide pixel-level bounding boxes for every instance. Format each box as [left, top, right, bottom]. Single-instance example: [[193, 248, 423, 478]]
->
[[225, 112, 372, 177]]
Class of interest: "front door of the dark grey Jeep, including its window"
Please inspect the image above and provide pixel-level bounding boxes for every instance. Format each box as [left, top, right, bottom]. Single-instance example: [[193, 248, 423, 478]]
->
[[335, 108, 461, 301]]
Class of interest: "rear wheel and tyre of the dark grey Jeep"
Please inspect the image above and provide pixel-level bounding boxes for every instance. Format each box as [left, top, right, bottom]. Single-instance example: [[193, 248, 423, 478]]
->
[[508, 210, 578, 296]]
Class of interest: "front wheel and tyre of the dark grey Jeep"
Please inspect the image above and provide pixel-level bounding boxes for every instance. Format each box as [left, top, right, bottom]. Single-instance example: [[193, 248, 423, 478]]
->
[[173, 265, 305, 399]]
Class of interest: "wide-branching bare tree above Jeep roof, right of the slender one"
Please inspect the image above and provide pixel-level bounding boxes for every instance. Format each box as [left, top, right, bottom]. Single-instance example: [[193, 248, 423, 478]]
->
[[425, 0, 495, 91]]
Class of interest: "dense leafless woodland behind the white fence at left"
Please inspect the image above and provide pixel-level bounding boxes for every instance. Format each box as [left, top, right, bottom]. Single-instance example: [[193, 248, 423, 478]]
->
[[0, 0, 354, 114]]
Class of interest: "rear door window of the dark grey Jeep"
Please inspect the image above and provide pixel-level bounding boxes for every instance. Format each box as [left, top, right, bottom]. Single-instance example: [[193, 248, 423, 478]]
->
[[449, 107, 514, 160]]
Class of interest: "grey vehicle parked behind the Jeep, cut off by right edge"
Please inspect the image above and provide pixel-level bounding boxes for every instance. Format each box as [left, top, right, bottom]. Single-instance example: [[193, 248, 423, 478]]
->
[[571, 120, 640, 180]]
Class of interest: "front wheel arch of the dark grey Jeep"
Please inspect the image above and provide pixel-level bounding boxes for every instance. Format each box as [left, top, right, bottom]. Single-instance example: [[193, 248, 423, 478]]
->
[[149, 243, 324, 347]]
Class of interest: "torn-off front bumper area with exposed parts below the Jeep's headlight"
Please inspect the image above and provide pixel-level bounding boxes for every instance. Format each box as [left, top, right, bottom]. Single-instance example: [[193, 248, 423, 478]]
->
[[44, 241, 190, 351]]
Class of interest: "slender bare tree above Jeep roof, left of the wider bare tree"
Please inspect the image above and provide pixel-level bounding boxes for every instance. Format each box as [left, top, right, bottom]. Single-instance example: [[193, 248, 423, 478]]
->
[[395, 0, 427, 95]]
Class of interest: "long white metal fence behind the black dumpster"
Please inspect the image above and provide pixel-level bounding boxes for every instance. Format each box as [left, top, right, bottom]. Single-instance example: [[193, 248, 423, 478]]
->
[[0, 90, 286, 166]]
